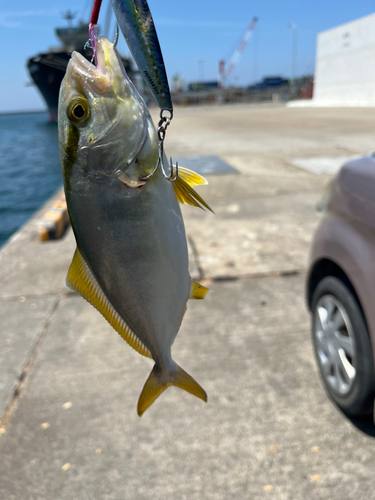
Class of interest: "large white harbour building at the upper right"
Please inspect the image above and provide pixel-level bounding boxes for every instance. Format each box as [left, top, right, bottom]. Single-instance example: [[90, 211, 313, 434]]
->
[[314, 14, 375, 106]]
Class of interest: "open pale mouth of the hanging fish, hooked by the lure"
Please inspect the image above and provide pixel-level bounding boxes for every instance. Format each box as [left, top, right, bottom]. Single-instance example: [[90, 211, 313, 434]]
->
[[71, 37, 121, 95]]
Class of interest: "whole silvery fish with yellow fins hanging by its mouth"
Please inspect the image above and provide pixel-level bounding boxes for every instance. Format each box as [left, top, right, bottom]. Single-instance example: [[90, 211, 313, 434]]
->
[[58, 37, 212, 416]]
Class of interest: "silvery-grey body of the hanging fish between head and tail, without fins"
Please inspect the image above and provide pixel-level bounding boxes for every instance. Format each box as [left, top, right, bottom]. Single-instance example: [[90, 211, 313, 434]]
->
[[67, 169, 191, 364]]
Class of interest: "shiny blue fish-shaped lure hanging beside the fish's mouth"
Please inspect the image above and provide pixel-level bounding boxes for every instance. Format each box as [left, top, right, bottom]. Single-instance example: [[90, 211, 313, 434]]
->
[[111, 0, 173, 113]]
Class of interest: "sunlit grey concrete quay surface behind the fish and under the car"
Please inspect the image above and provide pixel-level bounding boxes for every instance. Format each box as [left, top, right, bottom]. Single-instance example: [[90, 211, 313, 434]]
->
[[0, 106, 375, 500]]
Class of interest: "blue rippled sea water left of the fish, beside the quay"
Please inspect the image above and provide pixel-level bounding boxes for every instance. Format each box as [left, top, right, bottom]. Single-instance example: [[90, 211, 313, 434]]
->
[[0, 113, 62, 246]]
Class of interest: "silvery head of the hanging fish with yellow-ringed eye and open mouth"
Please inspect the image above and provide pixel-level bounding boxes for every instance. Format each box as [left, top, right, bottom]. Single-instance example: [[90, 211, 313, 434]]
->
[[59, 37, 158, 184]]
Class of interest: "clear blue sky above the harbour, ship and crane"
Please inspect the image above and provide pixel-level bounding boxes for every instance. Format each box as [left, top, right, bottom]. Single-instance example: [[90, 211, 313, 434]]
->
[[0, 0, 375, 112]]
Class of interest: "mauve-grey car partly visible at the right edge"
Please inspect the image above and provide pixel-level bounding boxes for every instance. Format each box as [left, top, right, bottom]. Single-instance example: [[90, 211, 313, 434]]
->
[[306, 156, 375, 416]]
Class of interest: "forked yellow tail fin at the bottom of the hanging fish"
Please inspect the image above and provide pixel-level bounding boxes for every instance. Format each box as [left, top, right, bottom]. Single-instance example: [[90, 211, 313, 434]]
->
[[137, 365, 207, 417]]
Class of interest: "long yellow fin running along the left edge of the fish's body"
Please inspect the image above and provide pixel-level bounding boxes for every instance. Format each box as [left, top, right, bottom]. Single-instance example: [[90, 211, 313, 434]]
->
[[66, 248, 152, 358]]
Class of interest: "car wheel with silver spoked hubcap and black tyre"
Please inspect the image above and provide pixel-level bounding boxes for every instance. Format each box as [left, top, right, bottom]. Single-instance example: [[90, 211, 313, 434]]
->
[[312, 276, 375, 416]]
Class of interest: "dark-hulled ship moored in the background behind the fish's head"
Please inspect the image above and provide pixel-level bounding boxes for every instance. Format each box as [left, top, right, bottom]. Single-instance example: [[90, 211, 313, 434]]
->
[[26, 11, 144, 122]]
